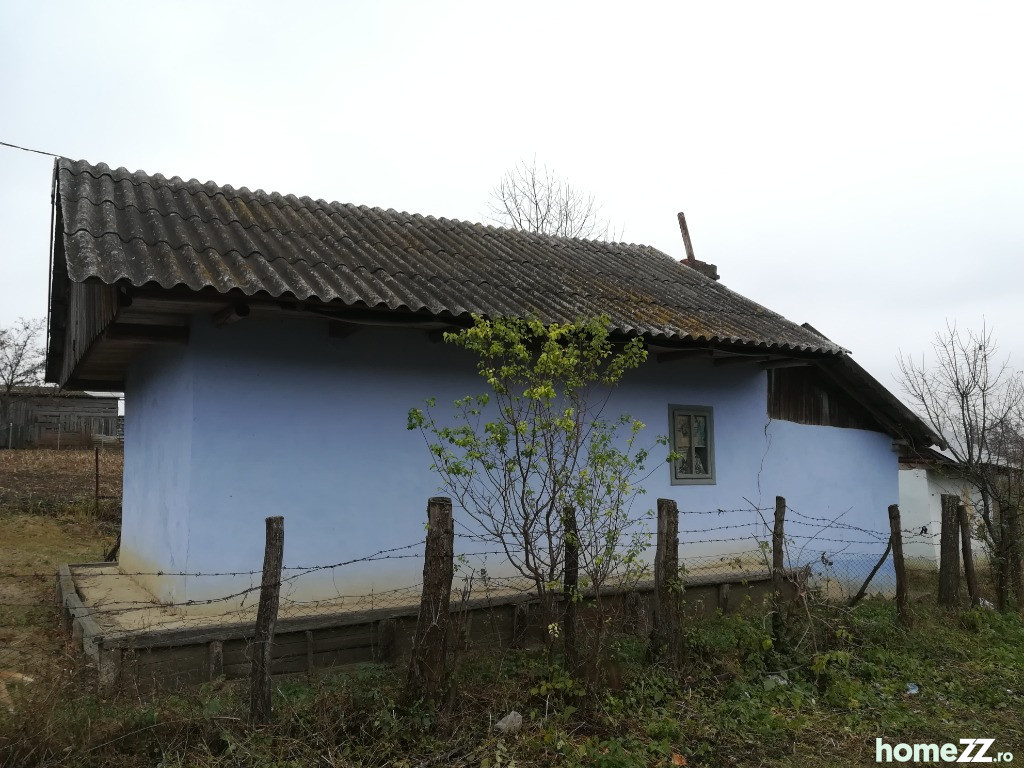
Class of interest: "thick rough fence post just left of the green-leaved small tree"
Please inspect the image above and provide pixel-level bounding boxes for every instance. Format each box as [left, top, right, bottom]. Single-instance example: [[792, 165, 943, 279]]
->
[[407, 497, 455, 701]]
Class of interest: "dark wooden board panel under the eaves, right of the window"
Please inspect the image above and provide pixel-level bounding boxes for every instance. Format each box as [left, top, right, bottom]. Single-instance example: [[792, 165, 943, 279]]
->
[[768, 366, 886, 431]]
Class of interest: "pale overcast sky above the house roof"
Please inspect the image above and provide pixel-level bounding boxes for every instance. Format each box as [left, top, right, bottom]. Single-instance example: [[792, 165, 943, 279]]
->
[[0, 1, 1024, 397]]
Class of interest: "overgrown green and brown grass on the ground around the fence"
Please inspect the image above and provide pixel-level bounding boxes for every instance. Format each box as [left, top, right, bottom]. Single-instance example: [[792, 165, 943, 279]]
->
[[0, 452, 1024, 768]]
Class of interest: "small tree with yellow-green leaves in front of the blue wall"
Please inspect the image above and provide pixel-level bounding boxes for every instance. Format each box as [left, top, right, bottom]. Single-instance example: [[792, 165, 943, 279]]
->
[[409, 317, 667, 651]]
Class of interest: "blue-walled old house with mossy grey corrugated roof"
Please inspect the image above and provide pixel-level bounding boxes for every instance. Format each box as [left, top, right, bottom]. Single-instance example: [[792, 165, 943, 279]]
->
[[46, 159, 937, 602]]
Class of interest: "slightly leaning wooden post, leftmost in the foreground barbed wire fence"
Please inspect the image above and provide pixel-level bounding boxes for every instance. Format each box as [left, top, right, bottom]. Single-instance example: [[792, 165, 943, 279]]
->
[[249, 516, 285, 724]]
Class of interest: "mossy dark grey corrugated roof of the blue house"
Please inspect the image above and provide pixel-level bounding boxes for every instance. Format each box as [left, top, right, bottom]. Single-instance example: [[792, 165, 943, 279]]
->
[[55, 159, 844, 354]]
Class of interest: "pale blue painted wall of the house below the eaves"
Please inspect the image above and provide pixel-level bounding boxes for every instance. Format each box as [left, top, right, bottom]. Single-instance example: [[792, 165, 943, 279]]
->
[[122, 317, 897, 599]]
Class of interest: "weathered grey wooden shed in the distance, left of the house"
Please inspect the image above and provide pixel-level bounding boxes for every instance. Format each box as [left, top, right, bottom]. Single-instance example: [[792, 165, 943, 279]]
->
[[0, 386, 119, 449]]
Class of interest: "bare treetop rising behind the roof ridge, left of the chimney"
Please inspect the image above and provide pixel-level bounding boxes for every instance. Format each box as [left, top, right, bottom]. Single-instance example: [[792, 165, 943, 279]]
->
[[489, 157, 622, 240]]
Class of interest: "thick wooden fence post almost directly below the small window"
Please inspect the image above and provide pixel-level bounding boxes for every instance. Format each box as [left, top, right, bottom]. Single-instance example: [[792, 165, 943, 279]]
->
[[648, 499, 682, 664]]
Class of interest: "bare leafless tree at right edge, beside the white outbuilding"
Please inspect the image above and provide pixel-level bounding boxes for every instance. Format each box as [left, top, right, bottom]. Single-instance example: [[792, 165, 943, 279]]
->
[[899, 323, 1024, 608]]
